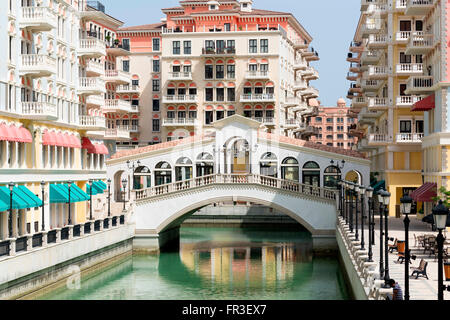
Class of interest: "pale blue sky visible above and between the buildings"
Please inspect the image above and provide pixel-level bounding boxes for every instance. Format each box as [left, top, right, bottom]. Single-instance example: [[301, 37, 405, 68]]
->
[[100, 0, 360, 106]]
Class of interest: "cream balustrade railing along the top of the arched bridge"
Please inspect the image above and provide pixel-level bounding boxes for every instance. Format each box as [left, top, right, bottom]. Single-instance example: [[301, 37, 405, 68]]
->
[[135, 174, 337, 200]]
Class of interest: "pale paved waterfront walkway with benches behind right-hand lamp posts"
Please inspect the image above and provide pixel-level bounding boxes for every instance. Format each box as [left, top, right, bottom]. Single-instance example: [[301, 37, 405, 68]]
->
[[352, 216, 442, 300]]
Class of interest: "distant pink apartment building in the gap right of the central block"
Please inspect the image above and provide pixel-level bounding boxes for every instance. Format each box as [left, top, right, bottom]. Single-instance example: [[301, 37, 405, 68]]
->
[[310, 98, 357, 149]]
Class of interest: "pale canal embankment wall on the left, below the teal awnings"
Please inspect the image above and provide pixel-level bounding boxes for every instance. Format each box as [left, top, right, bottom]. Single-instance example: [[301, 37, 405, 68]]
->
[[0, 215, 135, 300]]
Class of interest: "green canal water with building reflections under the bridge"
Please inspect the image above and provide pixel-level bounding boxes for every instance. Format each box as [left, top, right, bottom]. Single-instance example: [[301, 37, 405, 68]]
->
[[37, 228, 350, 300]]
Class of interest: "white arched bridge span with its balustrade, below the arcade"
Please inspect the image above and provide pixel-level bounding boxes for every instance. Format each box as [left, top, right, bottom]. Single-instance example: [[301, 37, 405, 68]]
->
[[134, 174, 337, 249]]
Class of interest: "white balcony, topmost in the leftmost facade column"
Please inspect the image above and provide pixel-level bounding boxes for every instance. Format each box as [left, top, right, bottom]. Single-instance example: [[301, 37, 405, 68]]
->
[[19, 7, 58, 32]]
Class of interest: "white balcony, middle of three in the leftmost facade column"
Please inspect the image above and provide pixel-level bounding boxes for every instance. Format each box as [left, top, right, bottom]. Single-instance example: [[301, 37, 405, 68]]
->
[[20, 54, 56, 78]]
